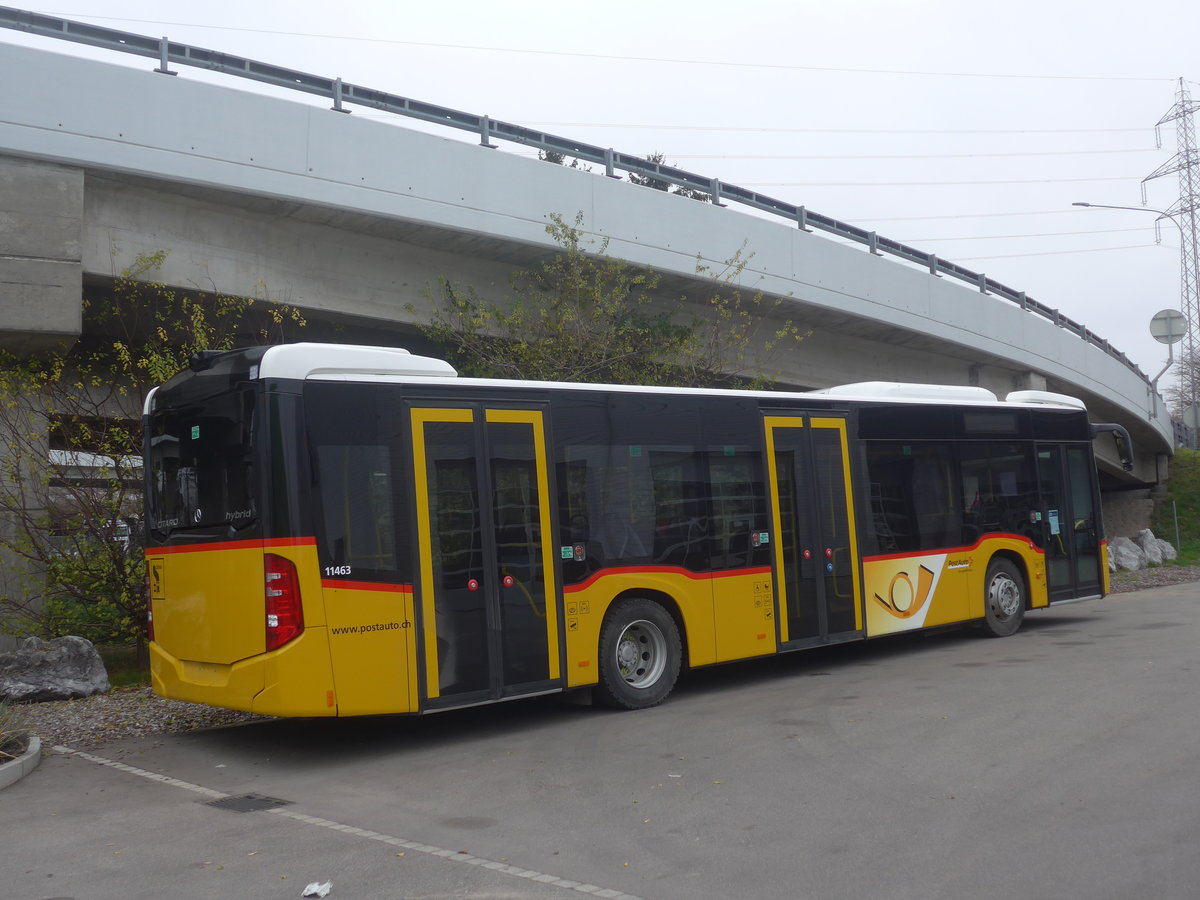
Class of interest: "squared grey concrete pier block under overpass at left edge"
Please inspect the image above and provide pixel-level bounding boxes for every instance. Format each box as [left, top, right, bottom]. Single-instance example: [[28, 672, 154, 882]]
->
[[0, 156, 83, 353]]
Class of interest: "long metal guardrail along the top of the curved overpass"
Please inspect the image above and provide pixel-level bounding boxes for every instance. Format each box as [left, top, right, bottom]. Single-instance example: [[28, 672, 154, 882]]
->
[[0, 6, 1150, 385]]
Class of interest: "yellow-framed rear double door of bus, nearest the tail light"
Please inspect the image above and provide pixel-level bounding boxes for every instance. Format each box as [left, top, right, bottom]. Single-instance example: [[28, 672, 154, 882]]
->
[[410, 404, 560, 709]]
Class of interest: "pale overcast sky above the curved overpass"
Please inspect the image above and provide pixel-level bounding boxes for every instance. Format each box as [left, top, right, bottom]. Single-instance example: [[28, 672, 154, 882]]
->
[[0, 0, 1200, 383]]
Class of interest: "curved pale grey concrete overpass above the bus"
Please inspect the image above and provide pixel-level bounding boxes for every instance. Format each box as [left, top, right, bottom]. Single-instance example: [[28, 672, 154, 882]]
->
[[0, 33, 1172, 501]]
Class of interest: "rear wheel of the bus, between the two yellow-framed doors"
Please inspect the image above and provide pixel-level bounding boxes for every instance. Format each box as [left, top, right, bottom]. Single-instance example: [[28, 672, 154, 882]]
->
[[596, 598, 683, 709]]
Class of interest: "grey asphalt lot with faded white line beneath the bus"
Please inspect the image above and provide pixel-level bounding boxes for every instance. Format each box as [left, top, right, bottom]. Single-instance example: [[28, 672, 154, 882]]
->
[[0, 584, 1200, 900]]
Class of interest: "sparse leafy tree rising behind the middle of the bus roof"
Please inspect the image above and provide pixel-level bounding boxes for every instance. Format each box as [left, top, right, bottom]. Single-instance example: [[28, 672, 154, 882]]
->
[[424, 216, 808, 386]]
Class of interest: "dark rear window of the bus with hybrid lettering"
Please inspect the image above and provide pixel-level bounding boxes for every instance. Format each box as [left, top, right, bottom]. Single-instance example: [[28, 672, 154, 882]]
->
[[146, 390, 258, 534]]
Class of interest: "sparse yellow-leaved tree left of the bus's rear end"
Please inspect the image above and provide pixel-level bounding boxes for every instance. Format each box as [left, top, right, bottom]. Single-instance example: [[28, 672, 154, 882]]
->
[[0, 252, 304, 649]]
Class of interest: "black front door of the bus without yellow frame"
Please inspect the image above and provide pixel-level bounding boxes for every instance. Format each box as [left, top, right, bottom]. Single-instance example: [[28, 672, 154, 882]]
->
[[1038, 444, 1103, 602]]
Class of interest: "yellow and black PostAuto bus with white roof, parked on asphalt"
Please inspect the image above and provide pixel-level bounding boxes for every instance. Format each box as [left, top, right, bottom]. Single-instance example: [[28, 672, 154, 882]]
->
[[144, 343, 1128, 716]]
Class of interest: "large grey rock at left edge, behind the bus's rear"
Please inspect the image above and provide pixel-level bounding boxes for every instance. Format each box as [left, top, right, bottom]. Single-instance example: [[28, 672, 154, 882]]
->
[[0, 636, 109, 703]]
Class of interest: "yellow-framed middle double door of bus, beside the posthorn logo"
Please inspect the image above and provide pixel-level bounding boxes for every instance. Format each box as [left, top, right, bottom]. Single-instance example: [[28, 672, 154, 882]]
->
[[766, 413, 863, 649]]
